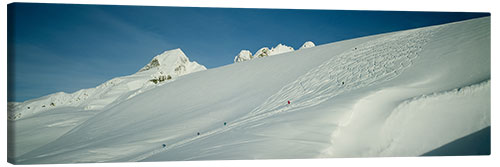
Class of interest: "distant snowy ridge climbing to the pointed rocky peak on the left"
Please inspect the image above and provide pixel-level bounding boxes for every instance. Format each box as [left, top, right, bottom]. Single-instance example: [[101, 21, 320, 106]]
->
[[8, 49, 207, 120]]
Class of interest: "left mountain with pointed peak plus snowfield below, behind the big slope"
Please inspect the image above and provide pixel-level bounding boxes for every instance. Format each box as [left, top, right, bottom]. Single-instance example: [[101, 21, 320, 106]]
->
[[8, 49, 206, 157]]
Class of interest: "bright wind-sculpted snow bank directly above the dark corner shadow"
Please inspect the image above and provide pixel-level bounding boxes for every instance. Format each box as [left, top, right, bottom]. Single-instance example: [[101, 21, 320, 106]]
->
[[371, 80, 491, 156]]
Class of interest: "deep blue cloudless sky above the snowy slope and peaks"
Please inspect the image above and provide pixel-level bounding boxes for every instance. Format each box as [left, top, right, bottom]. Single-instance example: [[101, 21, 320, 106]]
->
[[7, 3, 489, 102]]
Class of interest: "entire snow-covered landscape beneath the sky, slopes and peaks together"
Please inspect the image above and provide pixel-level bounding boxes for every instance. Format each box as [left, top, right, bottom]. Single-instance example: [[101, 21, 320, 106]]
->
[[8, 17, 491, 164]]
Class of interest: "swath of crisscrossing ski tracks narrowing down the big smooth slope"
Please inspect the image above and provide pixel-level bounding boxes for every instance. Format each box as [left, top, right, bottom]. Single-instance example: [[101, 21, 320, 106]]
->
[[130, 26, 442, 161]]
